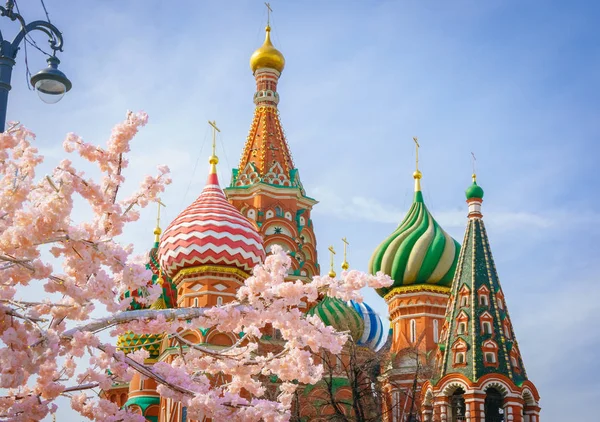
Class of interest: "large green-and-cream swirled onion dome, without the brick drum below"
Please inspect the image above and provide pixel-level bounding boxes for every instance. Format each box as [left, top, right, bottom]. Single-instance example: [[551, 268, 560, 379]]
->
[[369, 190, 460, 296]]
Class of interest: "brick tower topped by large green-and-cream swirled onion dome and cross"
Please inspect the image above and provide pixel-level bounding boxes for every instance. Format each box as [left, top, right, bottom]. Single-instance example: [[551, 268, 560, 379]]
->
[[369, 143, 460, 421]]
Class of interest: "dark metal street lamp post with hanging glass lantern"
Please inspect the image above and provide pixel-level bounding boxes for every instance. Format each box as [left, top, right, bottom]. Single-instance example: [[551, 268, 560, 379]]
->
[[0, 0, 72, 132]]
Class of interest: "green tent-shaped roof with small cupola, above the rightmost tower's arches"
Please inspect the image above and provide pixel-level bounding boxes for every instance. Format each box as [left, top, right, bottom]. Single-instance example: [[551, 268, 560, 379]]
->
[[437, 176, 527, 385]]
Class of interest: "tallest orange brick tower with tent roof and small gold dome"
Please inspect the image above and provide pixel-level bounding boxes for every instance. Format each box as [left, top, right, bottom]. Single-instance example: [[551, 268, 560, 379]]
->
[[225, 19, 319, 279]]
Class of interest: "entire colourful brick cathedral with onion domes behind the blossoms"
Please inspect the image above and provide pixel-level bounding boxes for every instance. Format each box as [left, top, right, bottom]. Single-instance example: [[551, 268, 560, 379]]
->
[[102, 14, 540, 422]]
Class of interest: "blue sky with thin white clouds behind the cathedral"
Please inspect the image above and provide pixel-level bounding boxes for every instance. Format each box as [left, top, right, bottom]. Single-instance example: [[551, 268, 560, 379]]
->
[[1, 0, 600, 422]]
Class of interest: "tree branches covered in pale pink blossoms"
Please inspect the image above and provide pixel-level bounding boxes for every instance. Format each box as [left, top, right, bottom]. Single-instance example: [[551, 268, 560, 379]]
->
[[0, 113, 391, 421]]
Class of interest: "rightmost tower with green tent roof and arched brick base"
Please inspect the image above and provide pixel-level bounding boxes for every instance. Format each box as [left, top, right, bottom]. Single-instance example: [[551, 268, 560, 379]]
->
[[423, 175, 540, 422]]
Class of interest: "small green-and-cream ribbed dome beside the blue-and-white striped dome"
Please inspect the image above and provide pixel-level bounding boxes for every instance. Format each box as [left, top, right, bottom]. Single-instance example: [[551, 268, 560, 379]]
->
[[307, 296, 364, 342]]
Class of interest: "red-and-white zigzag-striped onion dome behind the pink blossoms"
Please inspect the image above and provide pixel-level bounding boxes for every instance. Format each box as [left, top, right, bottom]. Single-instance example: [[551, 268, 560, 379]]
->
[[159, 173, 265, 278]]
